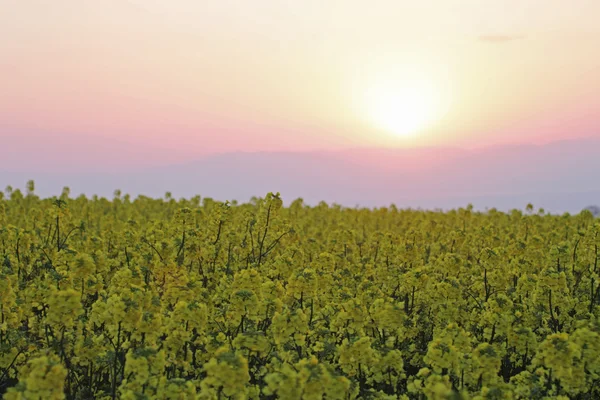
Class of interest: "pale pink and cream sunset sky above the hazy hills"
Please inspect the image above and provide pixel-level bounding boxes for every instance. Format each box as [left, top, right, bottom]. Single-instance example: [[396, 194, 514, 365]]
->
[[0, 0, 600, 167]]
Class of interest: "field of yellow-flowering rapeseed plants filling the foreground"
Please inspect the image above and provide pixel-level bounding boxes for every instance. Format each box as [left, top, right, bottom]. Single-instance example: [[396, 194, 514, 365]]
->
[[0, 186, 600, 399]]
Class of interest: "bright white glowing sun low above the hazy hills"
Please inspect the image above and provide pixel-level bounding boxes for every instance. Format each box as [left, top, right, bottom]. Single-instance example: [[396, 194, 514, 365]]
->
[[366, 81, 439, 138]]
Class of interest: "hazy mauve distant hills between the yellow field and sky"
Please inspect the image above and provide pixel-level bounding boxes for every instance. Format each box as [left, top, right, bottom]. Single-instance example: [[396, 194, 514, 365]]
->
[[0, 139, 600, 212]]
